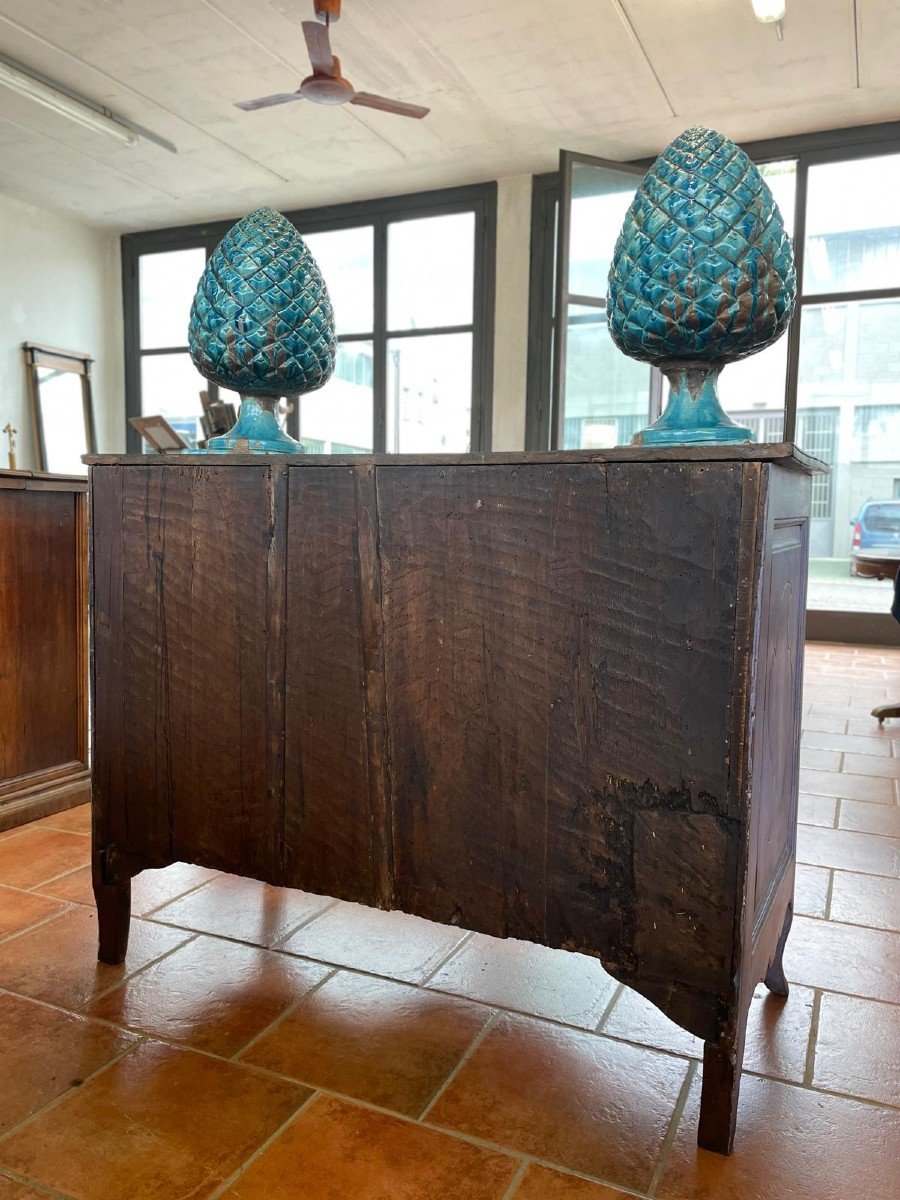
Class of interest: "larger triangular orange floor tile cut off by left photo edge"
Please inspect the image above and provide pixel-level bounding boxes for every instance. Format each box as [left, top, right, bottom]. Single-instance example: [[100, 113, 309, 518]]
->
[[0, 992, 136, 1133]]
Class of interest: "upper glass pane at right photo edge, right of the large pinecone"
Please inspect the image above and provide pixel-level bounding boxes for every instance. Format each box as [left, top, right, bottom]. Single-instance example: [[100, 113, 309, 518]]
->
[[803, 155, 900, 294]]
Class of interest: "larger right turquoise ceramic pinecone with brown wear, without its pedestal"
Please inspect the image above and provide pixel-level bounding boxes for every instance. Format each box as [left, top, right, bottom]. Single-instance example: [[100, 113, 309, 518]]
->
[[607, 127, 797, 365]]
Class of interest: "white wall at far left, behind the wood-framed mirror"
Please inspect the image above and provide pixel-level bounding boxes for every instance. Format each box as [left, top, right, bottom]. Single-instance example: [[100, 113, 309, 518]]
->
[[0, 196, 125, 470]]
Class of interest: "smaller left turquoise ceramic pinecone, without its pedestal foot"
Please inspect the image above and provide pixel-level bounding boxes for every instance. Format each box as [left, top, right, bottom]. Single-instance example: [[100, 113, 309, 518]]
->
[[188, 209, 335, 397]]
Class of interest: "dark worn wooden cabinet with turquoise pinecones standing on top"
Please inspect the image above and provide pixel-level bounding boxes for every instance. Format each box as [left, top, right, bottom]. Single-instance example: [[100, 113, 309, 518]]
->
[[90, 444, 816, 1153]]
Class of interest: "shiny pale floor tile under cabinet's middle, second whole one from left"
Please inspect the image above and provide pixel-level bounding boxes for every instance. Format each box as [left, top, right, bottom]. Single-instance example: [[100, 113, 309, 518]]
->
[[281, 902, 466, 983]]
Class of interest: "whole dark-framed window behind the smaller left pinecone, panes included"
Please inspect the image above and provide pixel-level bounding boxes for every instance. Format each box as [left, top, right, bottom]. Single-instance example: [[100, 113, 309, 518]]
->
[[122, 184, 497, 454]]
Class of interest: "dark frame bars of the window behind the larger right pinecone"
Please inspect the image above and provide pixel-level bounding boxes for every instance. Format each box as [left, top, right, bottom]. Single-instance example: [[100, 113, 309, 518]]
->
[[526, 121, 900, 450]]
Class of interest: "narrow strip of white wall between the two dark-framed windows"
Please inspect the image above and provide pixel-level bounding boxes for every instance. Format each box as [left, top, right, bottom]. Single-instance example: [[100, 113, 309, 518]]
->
[[492, 175, 532, 450]]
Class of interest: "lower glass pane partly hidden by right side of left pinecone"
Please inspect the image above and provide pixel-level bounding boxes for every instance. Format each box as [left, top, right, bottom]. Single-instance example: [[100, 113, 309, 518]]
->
[[300, 342, 373, 454]]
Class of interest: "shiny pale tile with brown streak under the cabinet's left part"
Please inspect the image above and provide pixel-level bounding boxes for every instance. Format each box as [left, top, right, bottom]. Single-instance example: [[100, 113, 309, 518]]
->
[[154, 875, 331, 946]]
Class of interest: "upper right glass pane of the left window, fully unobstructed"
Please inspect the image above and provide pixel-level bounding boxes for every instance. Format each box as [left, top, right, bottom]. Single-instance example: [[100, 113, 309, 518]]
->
[[388, 212, 475, 329]]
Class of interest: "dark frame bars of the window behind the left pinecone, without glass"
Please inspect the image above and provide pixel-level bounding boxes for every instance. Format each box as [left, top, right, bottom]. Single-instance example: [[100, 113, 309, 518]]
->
[[121, 181, 497, 454]]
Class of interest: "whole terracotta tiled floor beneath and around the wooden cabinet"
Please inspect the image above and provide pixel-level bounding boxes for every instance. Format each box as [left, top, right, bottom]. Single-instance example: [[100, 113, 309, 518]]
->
[[0, 646, 900, 1200]]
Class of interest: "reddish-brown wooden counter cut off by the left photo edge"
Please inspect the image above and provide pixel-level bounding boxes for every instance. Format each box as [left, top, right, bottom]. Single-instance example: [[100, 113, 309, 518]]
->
[[0, 470, 90, 830]]
